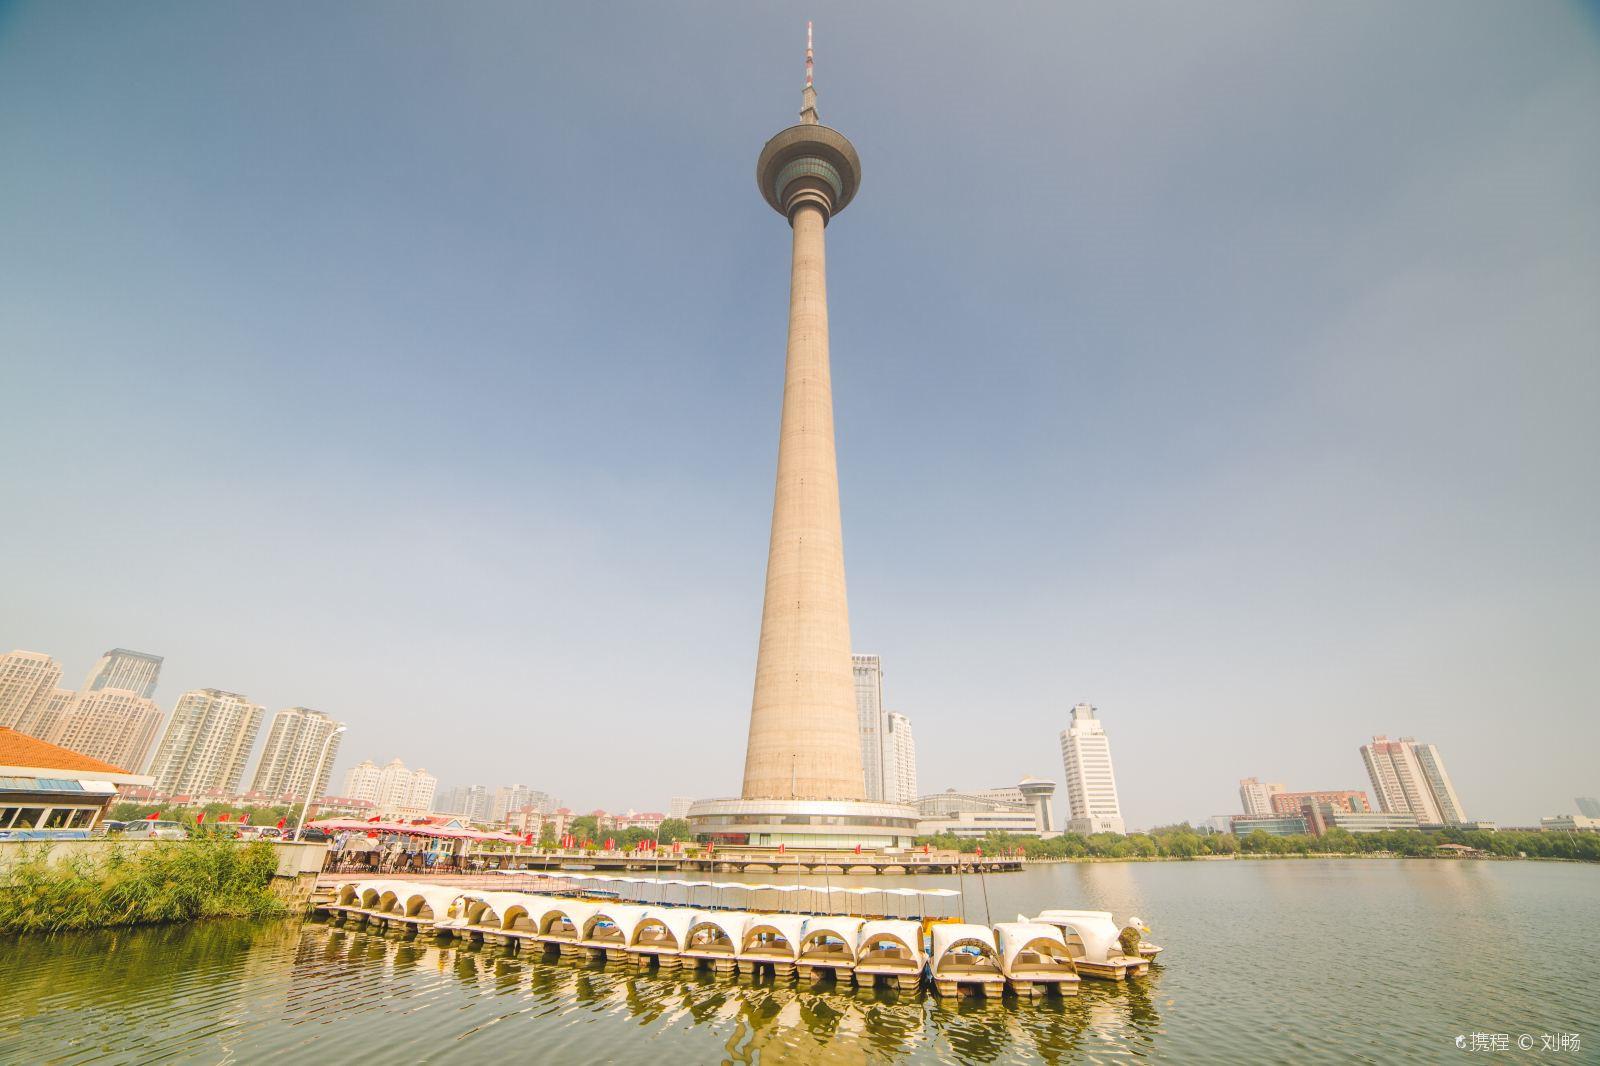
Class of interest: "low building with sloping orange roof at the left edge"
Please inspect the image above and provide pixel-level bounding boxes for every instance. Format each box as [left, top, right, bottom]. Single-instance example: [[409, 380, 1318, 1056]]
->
[[0, 727, 150, 839]]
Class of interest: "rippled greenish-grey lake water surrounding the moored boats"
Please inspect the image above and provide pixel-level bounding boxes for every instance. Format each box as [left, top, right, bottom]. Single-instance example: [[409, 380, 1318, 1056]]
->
[[0, 860, 1600, 1064]]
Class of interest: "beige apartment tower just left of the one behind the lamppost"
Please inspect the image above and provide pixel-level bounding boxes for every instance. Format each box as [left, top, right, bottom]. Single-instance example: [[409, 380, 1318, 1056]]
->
[[149, 688, 264, 795]]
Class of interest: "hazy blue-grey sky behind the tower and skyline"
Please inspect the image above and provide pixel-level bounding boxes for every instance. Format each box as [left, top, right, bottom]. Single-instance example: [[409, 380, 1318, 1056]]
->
[[0, 0, 1600, 826]]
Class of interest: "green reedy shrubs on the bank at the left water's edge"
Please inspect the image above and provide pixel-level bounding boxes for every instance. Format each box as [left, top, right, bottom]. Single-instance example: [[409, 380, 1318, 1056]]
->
[[0, 837, 285, 935]]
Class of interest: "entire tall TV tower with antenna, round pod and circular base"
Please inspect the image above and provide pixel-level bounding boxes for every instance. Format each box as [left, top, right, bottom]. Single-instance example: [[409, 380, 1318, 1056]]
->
[[688, 33, 917, 848]]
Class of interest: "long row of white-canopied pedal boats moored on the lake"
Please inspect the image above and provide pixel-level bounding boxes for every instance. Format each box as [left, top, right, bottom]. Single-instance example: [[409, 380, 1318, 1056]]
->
[[318, 880, 1162, 999]]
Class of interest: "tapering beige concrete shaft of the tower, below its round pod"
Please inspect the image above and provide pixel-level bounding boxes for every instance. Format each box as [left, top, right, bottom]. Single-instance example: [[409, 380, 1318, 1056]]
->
[[742, 202, 866, 800]]
